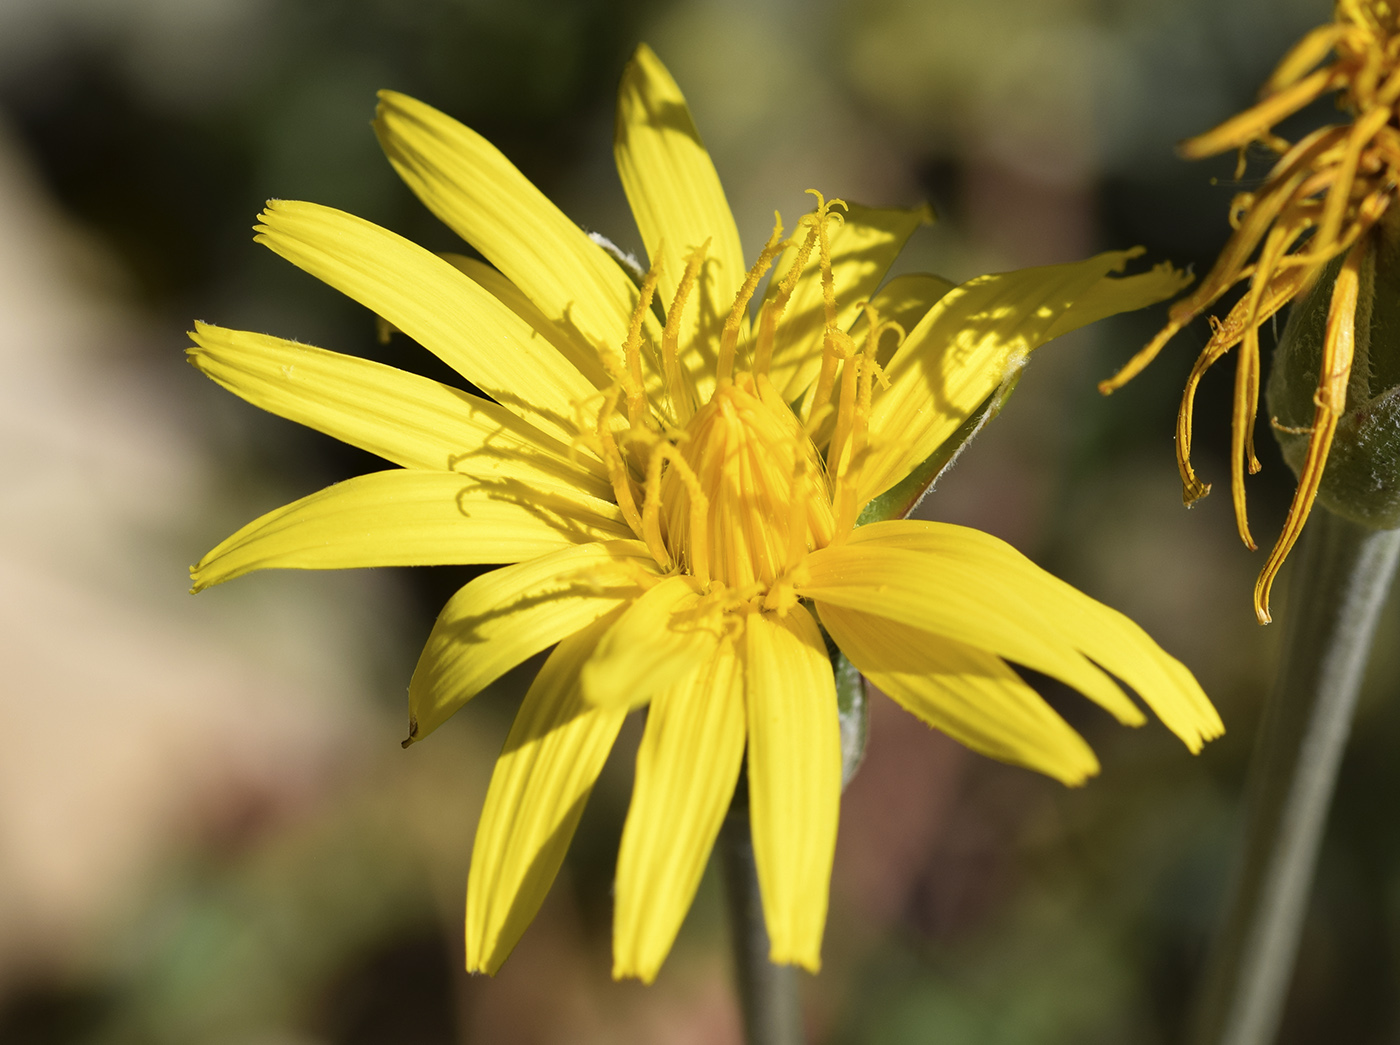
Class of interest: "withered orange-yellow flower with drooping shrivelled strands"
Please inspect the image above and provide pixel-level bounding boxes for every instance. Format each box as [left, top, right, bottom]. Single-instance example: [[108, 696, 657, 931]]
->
[[1099, 0, 1400, 623]]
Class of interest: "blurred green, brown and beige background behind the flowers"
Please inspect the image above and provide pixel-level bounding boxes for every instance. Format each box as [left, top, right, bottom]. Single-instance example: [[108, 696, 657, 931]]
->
[[0, 0, 1400, 1045]]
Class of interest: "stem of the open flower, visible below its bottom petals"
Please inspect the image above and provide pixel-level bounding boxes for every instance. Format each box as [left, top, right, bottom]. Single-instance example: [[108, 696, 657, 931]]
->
[[720, 776, 802, 1045]]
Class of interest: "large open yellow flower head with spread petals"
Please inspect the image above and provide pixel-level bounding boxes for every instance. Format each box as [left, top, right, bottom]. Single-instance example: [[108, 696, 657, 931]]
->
[[190, 48, 1221, 981]]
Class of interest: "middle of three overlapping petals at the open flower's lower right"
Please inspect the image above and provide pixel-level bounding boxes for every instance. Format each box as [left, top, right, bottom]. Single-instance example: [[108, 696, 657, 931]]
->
[[798, 524, 1144, 726]]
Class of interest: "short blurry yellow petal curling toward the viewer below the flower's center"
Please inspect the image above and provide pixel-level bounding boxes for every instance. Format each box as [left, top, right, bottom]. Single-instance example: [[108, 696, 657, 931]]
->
[[582, 576, 724, 707]]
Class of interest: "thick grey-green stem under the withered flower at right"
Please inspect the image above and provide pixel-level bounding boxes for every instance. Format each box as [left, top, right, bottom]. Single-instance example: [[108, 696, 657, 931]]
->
[[1193, 510, 1400, 1045]]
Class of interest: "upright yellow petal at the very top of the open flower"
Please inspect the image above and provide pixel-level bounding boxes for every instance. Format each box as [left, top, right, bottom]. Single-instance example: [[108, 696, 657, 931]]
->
[[613, 43, 749, 392]]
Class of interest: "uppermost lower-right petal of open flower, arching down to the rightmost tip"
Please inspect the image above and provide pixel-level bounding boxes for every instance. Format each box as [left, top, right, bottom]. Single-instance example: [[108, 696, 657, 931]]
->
[[851, 520, 1225, 751]]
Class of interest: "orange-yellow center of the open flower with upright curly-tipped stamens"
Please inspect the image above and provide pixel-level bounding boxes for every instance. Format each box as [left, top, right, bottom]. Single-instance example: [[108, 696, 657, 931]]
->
[[581, 191, 899, 612]]
